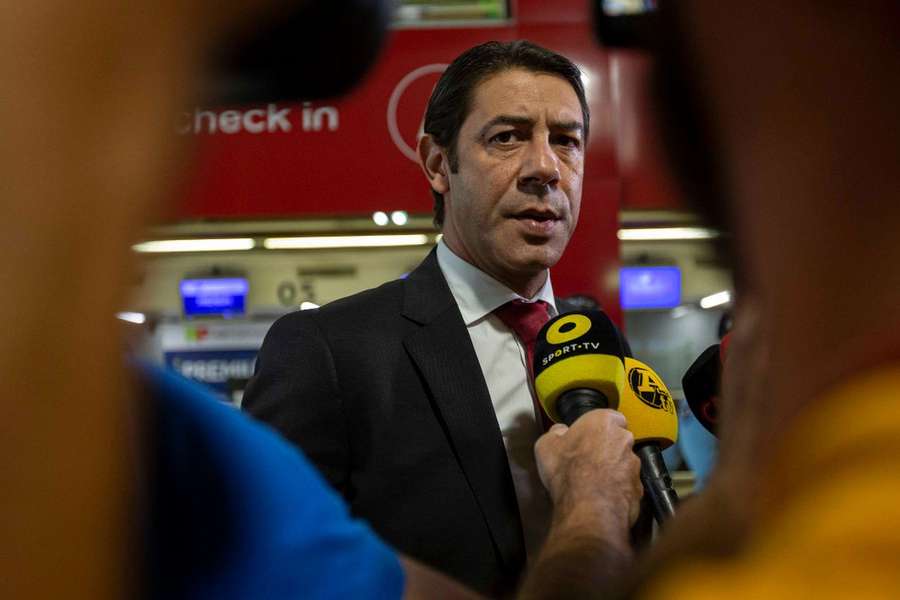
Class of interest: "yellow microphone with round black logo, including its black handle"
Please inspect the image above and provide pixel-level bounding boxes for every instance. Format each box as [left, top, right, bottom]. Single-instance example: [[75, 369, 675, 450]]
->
[[619, 356, 678, 524]]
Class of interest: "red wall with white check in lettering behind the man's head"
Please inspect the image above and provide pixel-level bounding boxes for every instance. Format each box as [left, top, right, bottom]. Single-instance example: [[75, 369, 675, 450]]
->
[[177, 0, 684, 324]]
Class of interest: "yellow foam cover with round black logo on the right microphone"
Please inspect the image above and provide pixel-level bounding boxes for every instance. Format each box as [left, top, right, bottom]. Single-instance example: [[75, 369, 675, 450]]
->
[[619, 356, 678, 448]]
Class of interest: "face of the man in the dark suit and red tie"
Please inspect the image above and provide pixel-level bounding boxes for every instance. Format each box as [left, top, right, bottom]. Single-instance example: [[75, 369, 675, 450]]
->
[[443, 69, 584, 293]]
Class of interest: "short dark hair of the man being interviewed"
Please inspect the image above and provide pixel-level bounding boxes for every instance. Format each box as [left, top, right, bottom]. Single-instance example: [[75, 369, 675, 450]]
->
[[424, 40, 591, 227]]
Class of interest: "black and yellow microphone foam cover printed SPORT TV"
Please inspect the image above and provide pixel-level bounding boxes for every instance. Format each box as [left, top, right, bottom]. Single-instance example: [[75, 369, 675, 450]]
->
[[533, 310, 625, 423]]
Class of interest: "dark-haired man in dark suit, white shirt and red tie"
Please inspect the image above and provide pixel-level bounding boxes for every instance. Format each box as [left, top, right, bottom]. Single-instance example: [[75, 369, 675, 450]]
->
[[244, 42, 589, 594]]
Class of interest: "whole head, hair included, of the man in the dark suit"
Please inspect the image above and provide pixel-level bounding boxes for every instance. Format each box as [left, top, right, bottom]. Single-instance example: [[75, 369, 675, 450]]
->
[[419, 41, 590, 296]]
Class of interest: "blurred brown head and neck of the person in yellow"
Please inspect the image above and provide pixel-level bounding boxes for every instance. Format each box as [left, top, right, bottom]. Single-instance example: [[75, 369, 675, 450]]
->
[[655, 0, 900, 418]]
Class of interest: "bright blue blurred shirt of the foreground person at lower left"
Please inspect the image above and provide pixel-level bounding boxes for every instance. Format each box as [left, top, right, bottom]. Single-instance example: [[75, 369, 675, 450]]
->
[[140, 365, 405, 600]]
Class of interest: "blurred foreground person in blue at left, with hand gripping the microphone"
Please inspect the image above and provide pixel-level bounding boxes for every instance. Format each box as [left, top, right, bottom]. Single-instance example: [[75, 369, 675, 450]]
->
[[0, 0, 640, 599]]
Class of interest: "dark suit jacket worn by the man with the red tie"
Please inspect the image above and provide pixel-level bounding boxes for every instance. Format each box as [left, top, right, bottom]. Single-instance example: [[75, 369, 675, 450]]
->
[[243, 251, 525, 594]]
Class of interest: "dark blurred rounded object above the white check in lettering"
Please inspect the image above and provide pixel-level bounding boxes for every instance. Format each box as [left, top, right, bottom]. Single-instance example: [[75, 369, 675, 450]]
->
[[204, 0, 393, 105]]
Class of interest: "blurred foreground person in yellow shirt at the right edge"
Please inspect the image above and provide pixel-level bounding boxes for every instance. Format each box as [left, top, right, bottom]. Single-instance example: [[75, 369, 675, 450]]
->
[[531, 0, 900, 599]]
